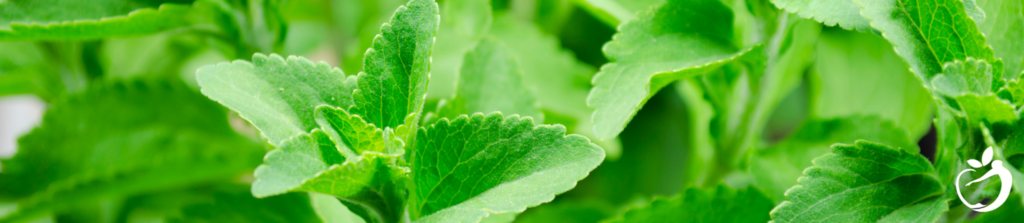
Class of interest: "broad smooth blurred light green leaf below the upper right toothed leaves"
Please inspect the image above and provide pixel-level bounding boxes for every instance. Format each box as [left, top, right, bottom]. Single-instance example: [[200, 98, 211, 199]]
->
[[800, 23, 934, 138]]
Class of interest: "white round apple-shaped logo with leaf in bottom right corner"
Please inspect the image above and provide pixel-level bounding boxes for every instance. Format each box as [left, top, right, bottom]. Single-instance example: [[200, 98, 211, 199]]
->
[[955, 147, 1014, 212]]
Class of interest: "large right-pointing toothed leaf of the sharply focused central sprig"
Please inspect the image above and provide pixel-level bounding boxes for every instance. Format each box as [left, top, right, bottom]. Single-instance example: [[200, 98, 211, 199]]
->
[[409, 113, 604, 222]]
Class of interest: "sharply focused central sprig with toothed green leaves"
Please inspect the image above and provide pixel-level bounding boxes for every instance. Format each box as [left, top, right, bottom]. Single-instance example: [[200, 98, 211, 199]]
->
[[197, 0, 604, 222]]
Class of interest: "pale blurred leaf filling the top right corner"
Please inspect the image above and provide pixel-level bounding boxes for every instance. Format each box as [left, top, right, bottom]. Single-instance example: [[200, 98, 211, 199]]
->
[[978, 0, 1024, 79]]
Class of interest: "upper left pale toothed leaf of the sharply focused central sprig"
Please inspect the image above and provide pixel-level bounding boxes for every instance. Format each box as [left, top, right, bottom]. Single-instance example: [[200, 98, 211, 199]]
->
[[196, 53, 356, 145]]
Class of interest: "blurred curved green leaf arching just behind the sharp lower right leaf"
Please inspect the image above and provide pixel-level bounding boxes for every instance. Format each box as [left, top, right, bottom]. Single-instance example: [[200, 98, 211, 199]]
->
[[748, 116, 920, 202]]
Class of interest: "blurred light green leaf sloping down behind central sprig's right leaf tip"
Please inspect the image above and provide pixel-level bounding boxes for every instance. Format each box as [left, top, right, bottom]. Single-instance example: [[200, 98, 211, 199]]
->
[[490, 14, 622, 159]]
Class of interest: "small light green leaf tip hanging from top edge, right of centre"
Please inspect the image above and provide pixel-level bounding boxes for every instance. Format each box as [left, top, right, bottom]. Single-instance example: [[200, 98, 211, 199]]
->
[[580, 0, 666, 27]]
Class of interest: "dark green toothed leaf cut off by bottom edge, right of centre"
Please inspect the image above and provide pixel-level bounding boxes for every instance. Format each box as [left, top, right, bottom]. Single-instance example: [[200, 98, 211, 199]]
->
[[609, 186, 774, 222]]
